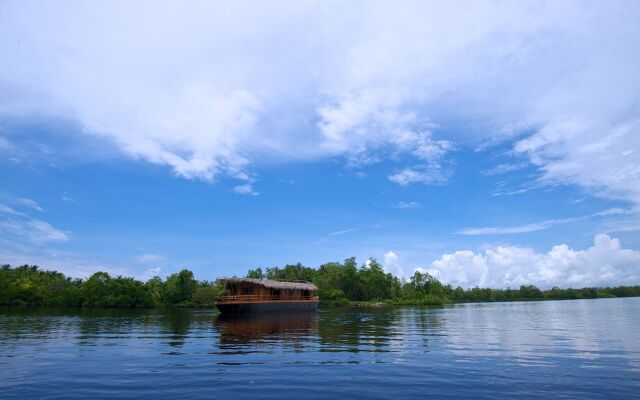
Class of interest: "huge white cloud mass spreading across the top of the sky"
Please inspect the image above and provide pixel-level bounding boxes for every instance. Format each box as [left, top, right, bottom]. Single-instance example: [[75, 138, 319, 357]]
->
[[0, 0, 640, 198]]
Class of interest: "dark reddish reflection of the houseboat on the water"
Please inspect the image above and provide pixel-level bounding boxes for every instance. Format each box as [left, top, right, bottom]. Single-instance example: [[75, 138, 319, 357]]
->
[[215, 312, 319, 345]]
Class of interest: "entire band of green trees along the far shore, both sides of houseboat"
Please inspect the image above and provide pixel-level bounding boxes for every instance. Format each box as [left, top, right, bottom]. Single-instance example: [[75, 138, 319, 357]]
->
[[0, 258, 640, 308]]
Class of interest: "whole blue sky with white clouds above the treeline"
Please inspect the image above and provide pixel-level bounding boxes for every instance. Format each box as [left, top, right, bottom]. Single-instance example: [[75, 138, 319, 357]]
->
[[0, 2, 640, 287]]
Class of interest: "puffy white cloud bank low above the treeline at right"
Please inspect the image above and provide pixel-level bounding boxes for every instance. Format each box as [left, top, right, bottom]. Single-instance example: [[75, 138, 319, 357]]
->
[[419, 234, 640, 288]]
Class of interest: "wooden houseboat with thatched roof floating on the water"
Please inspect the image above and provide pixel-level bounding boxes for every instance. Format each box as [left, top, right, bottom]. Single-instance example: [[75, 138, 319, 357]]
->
[[215, 278, 318, 314]]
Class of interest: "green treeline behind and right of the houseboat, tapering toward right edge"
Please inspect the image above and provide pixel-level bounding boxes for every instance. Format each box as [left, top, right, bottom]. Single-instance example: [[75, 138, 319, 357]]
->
[[247, 258, 640, 305]]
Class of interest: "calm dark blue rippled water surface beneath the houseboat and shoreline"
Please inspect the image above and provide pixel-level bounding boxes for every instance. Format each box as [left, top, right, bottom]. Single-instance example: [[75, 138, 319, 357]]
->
[[0, 298, 640, 399]]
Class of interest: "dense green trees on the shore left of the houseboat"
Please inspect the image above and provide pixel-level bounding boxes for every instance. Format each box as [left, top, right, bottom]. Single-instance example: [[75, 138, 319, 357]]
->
[[0, 265, 221, 308]]
